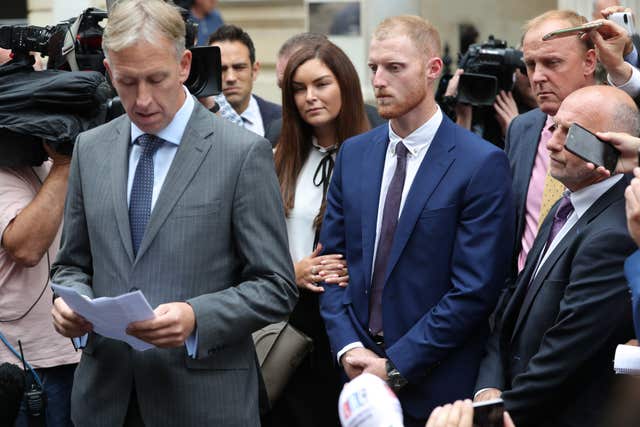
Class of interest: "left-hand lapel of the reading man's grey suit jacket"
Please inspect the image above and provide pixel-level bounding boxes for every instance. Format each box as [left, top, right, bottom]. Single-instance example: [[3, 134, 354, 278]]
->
[[110, 118, 134, 263]]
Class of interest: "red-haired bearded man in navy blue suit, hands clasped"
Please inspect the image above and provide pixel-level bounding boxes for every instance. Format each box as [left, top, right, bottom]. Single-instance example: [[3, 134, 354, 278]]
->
[[320, 16, 513, 427]]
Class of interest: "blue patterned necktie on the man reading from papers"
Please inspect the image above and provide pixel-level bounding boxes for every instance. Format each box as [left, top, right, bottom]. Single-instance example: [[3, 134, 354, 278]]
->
[[129, 133, 164, 255]]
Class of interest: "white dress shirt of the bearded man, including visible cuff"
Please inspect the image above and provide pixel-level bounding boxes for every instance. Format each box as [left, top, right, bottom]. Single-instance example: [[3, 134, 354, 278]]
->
[[337, 107, 442, 363]]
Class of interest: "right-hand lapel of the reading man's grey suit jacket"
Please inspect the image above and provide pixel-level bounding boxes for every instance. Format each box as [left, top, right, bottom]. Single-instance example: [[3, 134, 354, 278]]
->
[[135, 101, 213, 258]]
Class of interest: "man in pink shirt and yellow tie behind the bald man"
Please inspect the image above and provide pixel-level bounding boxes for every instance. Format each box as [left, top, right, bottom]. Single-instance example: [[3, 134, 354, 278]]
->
[[505, 10, 635, 281]]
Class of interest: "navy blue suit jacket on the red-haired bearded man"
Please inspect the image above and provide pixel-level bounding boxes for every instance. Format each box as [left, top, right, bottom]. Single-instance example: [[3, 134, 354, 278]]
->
[[320, 117, 514, 419]]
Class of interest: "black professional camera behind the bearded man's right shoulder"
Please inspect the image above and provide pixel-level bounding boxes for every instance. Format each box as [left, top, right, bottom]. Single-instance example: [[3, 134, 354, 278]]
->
[[457, 36, 526, 106]]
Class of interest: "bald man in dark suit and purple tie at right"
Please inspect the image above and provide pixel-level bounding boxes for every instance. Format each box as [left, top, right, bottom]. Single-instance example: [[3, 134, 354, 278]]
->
[[476, 86, 639, 427]]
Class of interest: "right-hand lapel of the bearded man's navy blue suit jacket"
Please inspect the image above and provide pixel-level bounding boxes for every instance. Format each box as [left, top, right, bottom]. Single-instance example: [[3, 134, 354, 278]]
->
[[385, 117, 455, 283]]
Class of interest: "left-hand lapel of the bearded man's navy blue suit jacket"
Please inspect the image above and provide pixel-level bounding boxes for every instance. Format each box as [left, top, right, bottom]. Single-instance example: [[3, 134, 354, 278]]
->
[[360, 126, 389, 287]]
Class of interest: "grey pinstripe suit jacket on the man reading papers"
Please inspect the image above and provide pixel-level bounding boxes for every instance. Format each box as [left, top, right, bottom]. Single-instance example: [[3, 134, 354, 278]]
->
[[52, 102, 297, 427]]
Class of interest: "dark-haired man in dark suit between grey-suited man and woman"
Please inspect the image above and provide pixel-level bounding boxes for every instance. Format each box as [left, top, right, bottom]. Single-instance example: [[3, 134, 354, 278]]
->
[[209, 25, 282, 136]]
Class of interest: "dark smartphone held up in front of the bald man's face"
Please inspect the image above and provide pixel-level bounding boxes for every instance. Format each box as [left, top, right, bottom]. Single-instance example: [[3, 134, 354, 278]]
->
[[565, 123, 620, 174]]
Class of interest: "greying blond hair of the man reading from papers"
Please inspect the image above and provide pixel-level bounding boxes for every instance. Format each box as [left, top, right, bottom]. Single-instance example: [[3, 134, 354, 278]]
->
[[102, 0, 186, 60]]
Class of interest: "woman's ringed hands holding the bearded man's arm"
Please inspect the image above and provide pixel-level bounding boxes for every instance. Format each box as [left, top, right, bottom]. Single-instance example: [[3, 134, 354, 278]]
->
[[294, 243, 349, 293]]
